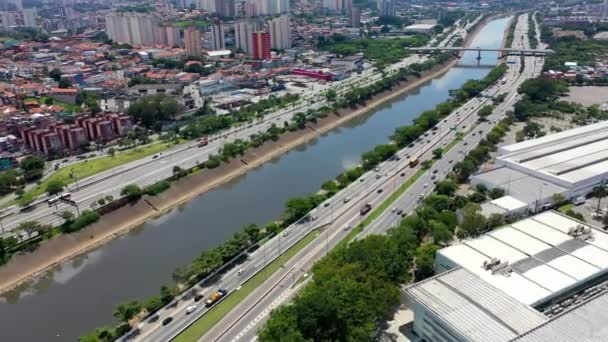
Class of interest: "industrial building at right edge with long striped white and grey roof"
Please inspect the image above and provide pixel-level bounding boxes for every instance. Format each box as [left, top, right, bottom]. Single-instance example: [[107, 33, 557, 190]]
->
[[471, 121, 608, 211]]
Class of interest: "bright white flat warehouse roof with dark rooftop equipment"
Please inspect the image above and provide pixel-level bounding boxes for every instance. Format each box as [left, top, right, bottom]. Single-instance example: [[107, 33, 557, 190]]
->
[[437, 211, 608, 305]]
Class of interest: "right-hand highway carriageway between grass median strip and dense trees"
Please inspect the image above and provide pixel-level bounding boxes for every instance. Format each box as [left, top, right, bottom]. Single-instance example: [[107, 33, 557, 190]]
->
[[199, 12, 542, 341]]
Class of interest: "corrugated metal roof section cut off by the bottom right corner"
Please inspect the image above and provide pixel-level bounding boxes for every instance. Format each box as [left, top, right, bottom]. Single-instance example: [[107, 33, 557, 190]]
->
[[512, 293, 608, 342]]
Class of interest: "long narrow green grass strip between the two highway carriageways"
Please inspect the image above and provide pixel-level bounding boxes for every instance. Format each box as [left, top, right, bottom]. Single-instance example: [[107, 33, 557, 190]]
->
[[173, 231, 319, 342]]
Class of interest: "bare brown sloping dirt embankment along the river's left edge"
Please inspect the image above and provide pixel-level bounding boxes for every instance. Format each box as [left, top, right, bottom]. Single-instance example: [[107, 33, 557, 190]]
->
[[0, 59, 458, 292]]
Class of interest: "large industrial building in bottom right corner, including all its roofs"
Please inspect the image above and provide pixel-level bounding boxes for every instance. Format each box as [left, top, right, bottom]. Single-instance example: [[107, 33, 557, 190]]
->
[[403, 211, 608, 342]]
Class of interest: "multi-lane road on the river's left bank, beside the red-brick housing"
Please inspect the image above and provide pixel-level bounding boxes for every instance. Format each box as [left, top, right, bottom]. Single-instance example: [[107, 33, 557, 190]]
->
[[0, 56, 425, 239]]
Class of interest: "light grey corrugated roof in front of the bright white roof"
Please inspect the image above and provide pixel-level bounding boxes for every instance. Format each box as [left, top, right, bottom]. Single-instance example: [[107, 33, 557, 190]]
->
[[405, 268, 547, 342]]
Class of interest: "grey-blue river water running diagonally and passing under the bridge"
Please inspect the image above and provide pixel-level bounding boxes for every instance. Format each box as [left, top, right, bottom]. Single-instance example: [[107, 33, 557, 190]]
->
[[0, 18, 508, 342]]
